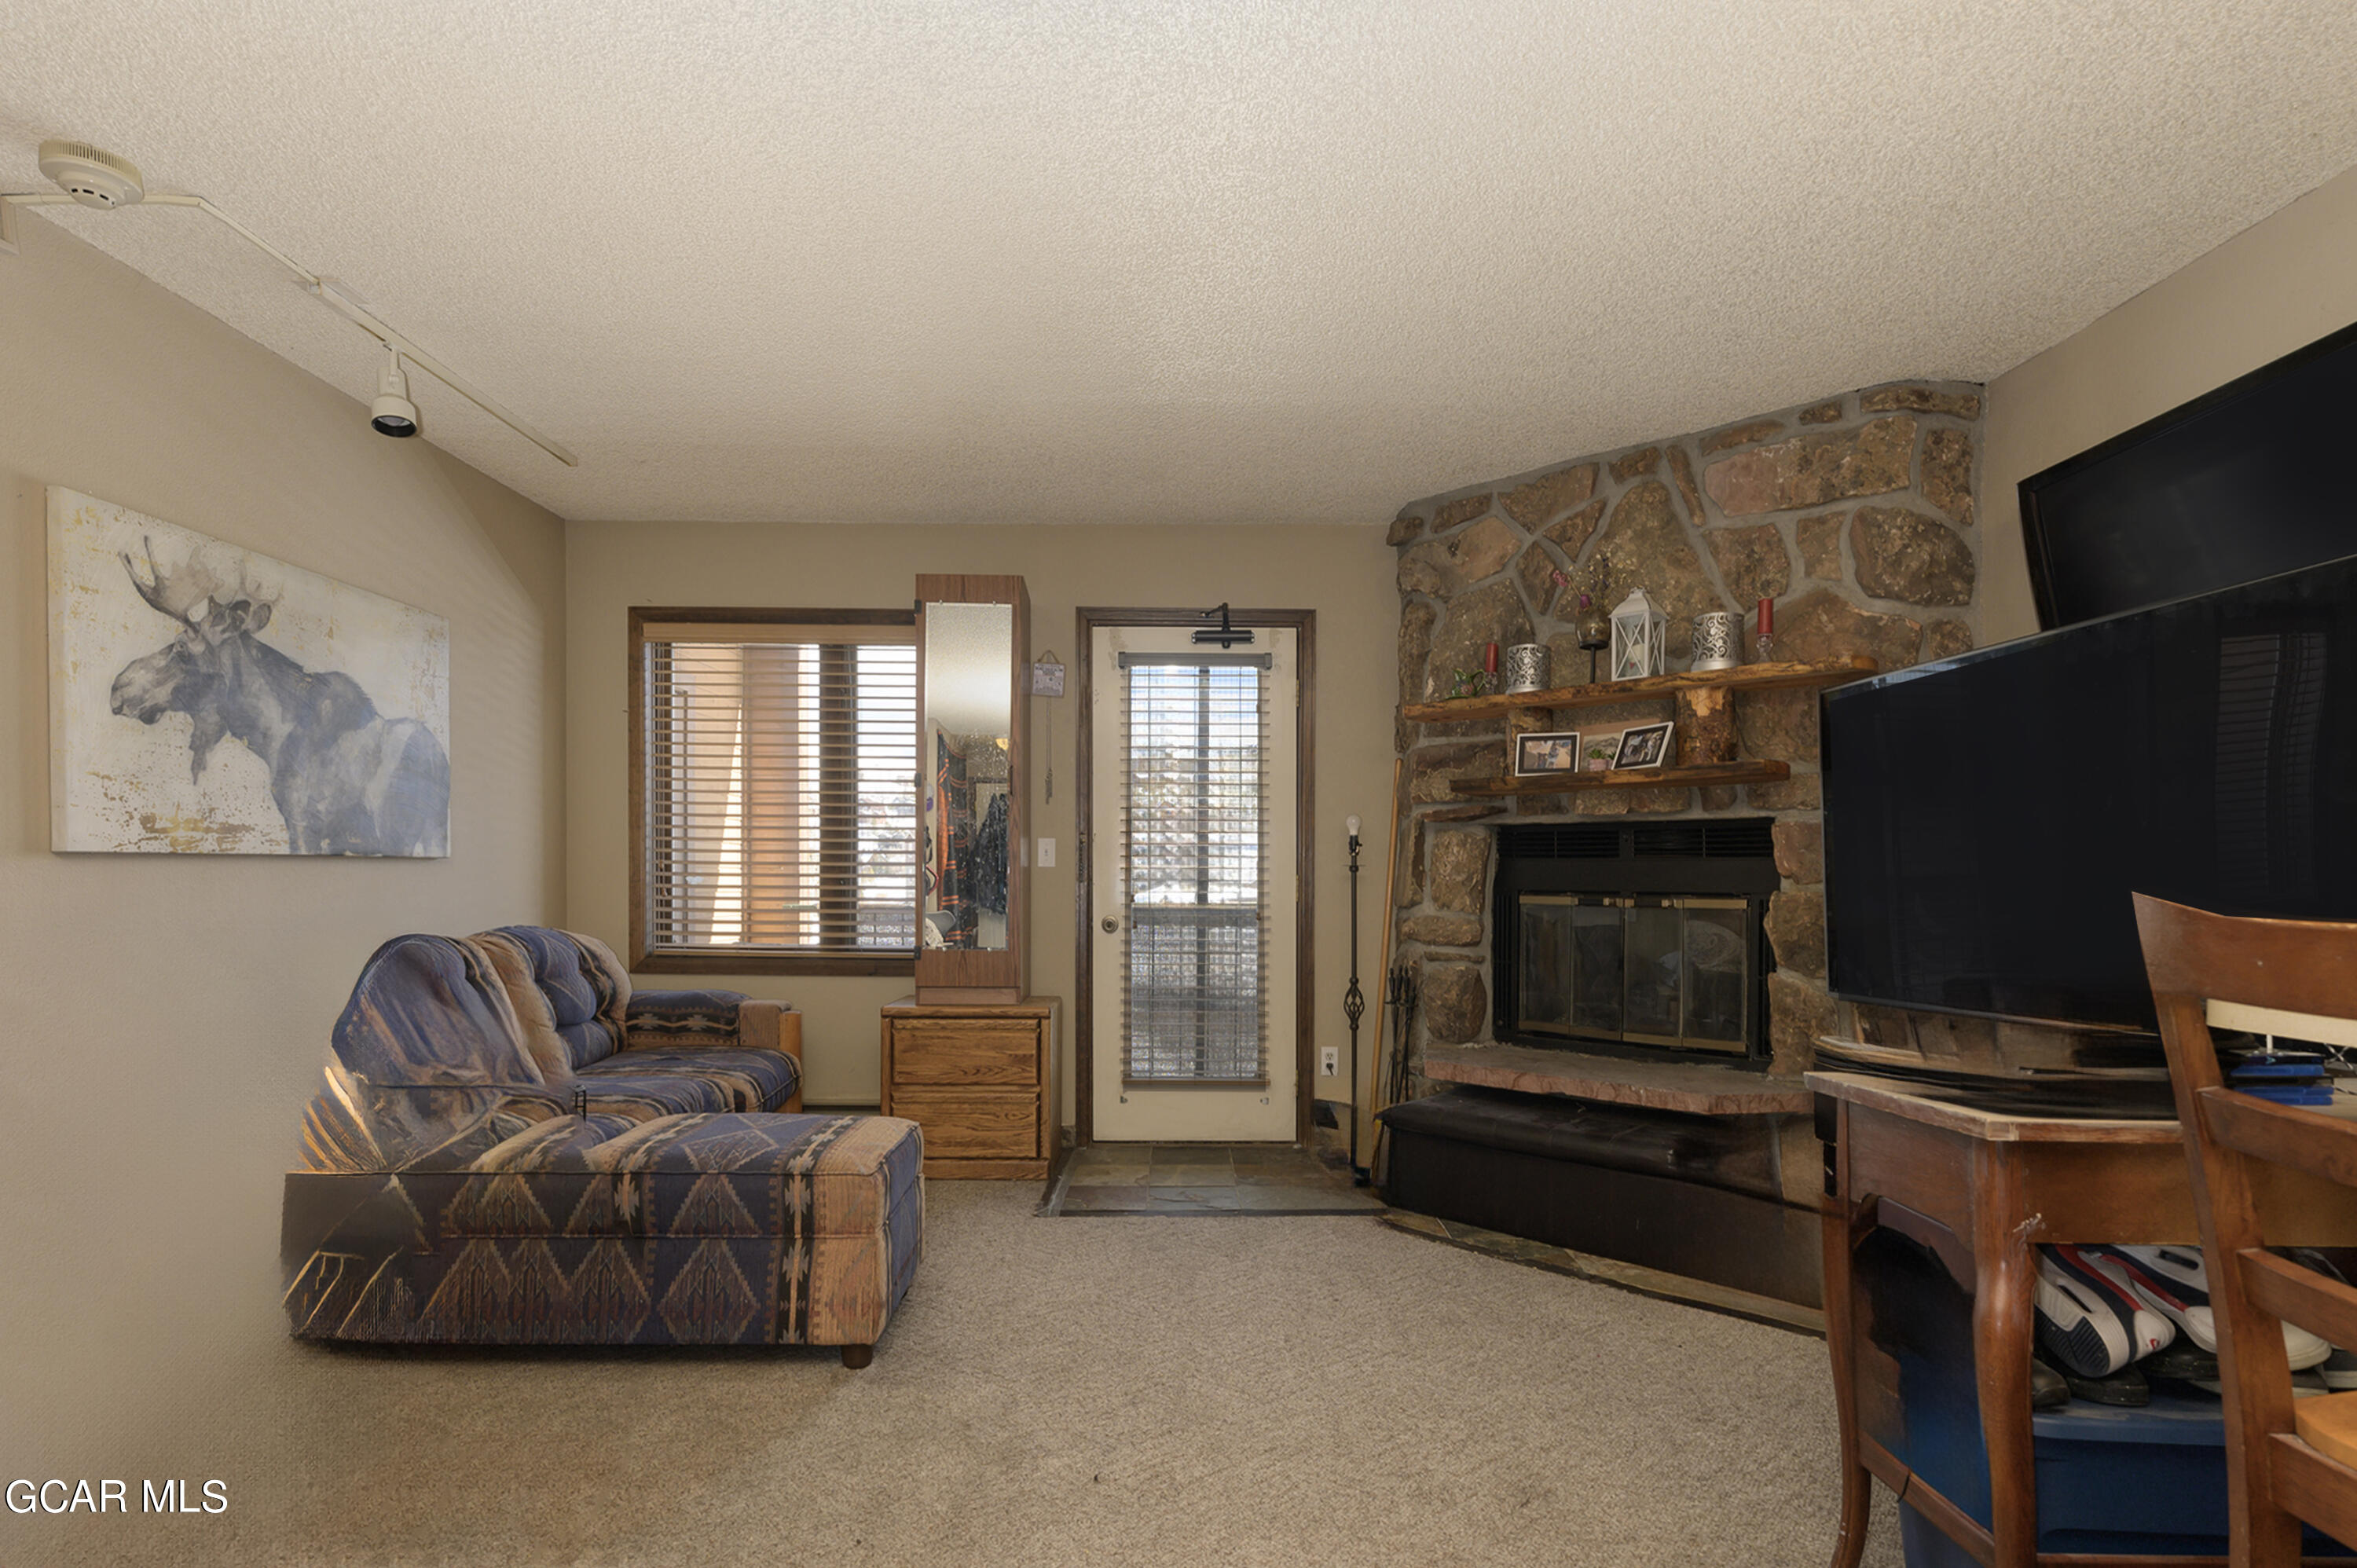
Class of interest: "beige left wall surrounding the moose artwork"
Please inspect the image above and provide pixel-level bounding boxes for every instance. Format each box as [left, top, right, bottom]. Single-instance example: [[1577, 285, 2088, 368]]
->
[[0, 219, 563, 1476]]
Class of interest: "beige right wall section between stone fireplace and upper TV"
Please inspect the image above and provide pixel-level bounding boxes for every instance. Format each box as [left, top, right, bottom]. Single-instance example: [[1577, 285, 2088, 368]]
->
[[1980, 159, 2357, 641]]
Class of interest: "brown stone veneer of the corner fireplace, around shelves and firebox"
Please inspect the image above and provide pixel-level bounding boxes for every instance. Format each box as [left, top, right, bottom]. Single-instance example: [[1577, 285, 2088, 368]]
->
[[1391, 382, 1982, 1090]]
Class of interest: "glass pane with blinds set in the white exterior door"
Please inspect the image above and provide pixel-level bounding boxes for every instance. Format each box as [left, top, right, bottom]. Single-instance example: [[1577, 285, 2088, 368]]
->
[[1120, 653, 1270, 1085]]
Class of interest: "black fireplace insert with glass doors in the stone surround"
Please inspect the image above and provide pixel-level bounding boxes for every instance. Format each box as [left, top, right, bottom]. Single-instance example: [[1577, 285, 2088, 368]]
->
[[1490, 816, 1777, 1064]]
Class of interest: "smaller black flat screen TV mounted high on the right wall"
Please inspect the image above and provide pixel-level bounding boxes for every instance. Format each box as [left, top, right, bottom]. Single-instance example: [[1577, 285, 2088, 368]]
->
[[2020, 311, 2357, 627]]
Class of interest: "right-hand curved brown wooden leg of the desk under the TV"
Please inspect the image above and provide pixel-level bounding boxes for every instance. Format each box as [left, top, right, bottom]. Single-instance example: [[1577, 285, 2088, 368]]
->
[[1973, 1144, 2039, 1568]]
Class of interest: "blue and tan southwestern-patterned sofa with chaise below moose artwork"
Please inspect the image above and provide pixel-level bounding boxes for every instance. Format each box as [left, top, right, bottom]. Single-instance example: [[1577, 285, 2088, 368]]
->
[[280, 927, 924, 1365]]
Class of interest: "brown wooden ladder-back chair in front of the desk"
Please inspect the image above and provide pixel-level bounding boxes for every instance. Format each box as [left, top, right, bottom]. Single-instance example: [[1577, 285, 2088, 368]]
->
[[2135, 894, 2357, 1568]]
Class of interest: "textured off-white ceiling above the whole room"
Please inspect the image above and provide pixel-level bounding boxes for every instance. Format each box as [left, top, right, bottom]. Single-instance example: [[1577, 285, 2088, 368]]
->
[[0, 0, 2357, 523]]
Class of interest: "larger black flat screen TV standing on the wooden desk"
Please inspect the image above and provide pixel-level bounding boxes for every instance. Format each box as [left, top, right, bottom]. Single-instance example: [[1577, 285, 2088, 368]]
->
[[1822, 556, 2357, 1031]]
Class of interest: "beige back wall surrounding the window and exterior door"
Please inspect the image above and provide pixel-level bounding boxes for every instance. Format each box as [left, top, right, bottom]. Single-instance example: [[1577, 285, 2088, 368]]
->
[[566, 523, 1398, 1125]]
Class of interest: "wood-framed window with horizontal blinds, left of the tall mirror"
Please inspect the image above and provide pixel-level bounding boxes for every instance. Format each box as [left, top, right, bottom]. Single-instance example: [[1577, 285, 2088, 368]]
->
[[632, 610, 917, 972]]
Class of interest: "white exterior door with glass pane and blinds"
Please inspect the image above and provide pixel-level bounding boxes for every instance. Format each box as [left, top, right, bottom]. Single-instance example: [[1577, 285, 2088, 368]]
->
[[1089, 627, 1301, 1144]]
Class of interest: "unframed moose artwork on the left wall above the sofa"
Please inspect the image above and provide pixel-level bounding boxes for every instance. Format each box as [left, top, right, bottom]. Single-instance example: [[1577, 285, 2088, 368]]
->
[[49, 488, 450, 856]]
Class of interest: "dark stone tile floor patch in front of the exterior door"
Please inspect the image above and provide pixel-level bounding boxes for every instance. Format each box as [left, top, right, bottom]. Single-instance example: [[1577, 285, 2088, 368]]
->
[[1039, 1144, 1384, 1214]]
